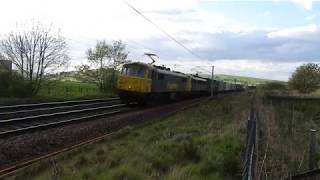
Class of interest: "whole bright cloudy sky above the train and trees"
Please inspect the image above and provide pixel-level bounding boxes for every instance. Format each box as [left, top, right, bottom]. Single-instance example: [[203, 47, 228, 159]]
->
[[0, 0, 320, 81]]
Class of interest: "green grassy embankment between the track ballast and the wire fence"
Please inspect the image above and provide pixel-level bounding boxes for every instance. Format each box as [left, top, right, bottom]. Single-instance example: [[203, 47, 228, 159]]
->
[[8, 93, 249, 180]]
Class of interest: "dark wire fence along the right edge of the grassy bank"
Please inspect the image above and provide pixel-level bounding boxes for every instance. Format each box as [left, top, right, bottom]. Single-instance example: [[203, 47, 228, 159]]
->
[[242, 97, 257, 180]]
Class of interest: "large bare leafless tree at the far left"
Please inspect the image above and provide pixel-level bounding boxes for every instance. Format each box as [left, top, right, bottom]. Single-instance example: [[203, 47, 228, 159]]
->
[[0, 22, 69, 94]]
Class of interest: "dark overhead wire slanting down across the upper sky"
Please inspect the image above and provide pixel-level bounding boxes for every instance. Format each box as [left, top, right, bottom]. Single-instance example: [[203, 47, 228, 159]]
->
[[123, 0, 202, 59]]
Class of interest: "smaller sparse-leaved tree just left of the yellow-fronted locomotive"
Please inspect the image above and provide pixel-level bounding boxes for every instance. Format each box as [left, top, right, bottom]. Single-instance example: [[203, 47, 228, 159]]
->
[[84, 41, 129, 92]]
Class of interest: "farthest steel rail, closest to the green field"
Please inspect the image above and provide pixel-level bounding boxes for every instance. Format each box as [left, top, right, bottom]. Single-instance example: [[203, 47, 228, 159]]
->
[[0, 98, 120, 111]]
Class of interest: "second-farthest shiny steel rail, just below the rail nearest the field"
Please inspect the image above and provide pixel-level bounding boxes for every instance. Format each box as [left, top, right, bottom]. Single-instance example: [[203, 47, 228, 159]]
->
[[0, 100, 120, 116]]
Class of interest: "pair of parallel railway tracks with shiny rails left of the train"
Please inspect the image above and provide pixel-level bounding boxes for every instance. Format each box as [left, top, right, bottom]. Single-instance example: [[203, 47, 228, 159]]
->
[[0, 98, 130, 137]]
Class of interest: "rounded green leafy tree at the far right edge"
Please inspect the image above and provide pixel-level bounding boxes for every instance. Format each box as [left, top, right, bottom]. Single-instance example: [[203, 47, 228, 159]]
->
[[289, 63, 320, 93]]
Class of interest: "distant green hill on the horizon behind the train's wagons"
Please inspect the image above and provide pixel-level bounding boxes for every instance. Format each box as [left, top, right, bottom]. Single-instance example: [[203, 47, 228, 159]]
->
[[196, 74, 281, 85]]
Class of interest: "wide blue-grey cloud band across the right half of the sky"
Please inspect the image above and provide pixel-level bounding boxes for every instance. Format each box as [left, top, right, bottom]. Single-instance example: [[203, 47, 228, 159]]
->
[[136, 25, 320, 62]]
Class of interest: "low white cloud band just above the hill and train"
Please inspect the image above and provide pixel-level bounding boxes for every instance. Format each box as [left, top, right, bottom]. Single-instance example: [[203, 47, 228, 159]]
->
[[149, 59, 307, 81]]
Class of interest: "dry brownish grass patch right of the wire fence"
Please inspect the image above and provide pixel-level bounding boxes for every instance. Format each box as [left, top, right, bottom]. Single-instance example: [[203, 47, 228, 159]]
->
[[259, 94, 320, 179]]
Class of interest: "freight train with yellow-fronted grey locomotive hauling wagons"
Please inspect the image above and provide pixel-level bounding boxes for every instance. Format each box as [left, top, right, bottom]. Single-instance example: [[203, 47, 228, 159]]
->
[[117, 62, 244, 104]]
